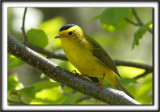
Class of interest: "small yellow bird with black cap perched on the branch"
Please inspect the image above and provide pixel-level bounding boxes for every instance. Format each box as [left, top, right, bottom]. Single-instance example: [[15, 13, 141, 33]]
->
[[55, 24, 133, 98]]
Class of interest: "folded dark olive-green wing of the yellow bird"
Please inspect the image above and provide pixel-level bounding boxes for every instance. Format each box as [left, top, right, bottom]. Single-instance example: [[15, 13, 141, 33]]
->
[[86, 36, 121, 77]]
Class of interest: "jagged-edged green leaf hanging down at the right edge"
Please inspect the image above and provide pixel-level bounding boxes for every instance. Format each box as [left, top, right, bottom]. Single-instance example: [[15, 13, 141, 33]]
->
[[132, 21, 152, 49]]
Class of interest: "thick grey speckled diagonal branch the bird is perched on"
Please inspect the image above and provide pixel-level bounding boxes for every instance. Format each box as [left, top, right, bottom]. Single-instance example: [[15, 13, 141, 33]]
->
[[8, 35, 140, 104]]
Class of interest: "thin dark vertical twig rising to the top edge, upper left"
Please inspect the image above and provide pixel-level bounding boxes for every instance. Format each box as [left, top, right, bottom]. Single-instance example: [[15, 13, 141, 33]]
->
[[21, 7, 27, 44]]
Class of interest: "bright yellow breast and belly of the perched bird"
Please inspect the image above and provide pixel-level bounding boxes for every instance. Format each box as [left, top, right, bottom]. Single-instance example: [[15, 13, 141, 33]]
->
[[61, 38, 112, 77]]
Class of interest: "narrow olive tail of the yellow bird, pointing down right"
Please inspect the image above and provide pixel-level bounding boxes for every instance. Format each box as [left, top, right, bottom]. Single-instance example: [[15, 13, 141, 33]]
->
[[115, 77, 134, 99]]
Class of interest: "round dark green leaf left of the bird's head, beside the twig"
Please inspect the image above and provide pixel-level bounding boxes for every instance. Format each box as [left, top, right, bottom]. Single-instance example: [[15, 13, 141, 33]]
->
[[27, 28, 48, 48]]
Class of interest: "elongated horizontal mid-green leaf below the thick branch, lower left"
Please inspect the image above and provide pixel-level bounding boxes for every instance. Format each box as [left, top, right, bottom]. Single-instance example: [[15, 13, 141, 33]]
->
[[33, 81, 60, 91]]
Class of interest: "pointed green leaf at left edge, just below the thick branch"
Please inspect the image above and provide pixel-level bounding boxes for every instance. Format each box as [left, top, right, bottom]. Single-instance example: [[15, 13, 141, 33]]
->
[[8, 54, 24, 70]]
